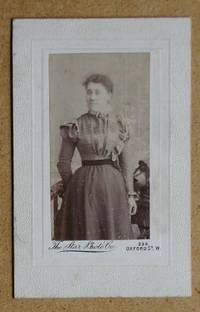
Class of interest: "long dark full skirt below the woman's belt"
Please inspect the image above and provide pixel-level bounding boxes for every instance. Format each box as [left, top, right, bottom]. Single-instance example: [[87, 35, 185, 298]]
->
[[54, 164, 133, 240]]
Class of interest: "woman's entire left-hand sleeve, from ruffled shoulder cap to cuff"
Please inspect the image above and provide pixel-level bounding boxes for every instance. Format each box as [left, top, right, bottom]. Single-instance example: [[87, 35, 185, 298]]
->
[[57, 121, 78, 186]]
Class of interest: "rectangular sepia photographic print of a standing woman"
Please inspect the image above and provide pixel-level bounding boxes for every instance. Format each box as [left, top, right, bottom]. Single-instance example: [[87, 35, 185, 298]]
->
[[49, 52, 151, 241]]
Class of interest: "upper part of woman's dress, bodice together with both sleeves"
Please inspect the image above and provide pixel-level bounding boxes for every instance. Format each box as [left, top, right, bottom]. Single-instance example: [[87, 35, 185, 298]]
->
[[57, 112, 133, 192]]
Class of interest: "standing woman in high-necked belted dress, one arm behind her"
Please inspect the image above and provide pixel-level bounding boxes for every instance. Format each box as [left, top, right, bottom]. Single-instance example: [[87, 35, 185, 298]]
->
[[54, 74, 136, 240]]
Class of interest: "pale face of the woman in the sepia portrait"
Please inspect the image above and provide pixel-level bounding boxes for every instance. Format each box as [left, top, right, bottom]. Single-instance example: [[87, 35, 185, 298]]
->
[[86, 82, 111, 111]]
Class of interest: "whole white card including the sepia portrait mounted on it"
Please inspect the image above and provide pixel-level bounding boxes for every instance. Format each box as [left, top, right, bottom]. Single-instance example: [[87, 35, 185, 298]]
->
[[13, 18, 191, 298]]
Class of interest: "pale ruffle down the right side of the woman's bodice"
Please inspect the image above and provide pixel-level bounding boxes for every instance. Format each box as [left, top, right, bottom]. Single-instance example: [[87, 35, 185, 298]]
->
[[112, 115, 130, 161]]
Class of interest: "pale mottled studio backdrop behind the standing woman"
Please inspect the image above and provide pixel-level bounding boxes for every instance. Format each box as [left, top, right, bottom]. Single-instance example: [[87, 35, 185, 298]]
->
[[49, 53, 150, 185]]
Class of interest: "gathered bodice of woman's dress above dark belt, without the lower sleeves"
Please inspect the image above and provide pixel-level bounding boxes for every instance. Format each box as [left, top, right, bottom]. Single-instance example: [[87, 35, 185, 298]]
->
[[61, 112, 129, 161]]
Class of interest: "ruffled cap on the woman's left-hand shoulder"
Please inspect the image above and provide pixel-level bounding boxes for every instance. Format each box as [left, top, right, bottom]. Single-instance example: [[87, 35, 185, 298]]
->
[[60, 119, 79, 142]]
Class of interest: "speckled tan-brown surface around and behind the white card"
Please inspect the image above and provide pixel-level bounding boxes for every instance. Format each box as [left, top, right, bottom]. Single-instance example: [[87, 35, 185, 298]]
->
[[0, 0, 200, 312]]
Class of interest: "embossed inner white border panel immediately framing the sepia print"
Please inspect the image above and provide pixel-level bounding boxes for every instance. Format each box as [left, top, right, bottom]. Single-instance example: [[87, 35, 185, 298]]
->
[[32, 38, 167, 266]]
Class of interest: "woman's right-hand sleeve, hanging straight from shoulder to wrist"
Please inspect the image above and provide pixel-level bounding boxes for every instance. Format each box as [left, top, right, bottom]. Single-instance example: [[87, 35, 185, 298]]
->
[[119, 118, 134, 193]]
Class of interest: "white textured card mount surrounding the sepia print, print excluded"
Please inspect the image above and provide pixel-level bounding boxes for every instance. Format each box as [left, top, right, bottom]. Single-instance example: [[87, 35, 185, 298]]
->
[[13, 18, 190, 298]]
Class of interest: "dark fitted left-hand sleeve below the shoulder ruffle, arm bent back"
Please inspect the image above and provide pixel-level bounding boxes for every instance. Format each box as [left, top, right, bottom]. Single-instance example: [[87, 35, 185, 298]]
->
[[57, 127, 76, 186]]
